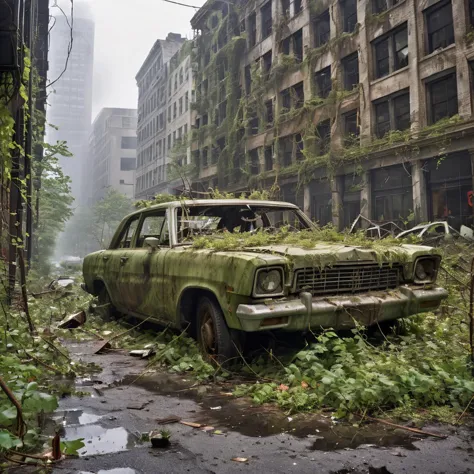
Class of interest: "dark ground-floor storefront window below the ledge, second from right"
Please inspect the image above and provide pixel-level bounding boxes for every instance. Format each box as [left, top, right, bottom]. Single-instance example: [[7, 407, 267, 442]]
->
[[371, 164, 413, 223]]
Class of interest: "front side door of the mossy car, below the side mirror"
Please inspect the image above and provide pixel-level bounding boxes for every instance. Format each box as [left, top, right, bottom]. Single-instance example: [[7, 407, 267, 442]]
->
[[120, 209, 170, 321]]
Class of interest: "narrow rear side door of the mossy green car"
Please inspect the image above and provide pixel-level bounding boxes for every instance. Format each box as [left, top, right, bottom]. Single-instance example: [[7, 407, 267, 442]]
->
[[99, 215, 140, 309]]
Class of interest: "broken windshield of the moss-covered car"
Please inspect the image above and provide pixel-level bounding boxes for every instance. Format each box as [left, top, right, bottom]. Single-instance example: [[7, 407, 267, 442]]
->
[[178, 204, 309, 243]]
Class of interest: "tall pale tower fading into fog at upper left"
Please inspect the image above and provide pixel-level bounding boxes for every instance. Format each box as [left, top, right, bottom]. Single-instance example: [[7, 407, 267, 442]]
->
[[47, 6, 94, 203]]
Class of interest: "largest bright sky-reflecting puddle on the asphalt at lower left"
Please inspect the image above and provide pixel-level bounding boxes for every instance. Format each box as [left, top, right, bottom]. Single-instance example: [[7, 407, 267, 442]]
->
[[64, 425, 137, 456]]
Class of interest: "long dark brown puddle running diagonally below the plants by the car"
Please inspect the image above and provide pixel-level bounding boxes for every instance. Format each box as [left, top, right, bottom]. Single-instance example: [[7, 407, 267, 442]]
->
[[121, 374, 419, 451]]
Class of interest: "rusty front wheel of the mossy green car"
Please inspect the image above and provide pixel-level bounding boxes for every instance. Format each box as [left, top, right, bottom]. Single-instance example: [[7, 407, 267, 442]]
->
[[197, 296, 238, 364]]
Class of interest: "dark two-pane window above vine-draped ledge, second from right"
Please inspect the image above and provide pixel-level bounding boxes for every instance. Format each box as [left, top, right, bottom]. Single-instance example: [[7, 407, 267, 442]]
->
[[374, 91, 410, 138]]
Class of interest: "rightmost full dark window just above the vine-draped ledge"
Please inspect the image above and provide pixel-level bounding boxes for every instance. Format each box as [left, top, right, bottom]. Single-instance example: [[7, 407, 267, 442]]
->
[[428, 72, 458, 123]]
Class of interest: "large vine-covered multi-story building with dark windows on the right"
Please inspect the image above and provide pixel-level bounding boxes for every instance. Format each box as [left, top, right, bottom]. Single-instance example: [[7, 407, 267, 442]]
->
[[191, 0, 474, 228]]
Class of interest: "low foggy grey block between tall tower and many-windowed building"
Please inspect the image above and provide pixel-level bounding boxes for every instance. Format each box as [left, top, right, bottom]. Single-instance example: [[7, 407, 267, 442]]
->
[[85, 108, 137, 205]]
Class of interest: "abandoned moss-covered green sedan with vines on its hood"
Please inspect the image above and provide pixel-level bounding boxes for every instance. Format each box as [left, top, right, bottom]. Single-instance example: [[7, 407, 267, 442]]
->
[[83, 199, 447, 358]]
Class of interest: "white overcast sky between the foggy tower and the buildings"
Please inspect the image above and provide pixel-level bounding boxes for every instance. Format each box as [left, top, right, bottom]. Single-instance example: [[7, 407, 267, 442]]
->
[[51, 0, 205, 119]]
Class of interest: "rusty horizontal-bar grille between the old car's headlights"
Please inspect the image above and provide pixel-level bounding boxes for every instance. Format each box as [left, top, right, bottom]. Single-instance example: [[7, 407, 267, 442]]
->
[[294, 262, 402, 295]]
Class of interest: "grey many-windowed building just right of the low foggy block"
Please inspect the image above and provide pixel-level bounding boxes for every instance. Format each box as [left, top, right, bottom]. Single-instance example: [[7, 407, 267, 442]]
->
[[135, 33, 185, 199]]
